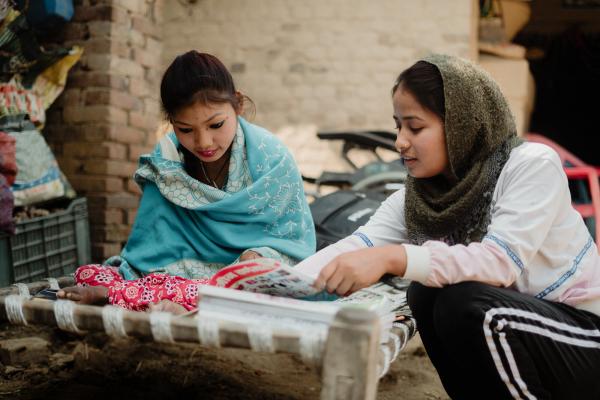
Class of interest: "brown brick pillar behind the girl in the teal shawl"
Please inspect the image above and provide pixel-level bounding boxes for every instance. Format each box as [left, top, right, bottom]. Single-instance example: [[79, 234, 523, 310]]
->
[[44, 0, 162, 261]]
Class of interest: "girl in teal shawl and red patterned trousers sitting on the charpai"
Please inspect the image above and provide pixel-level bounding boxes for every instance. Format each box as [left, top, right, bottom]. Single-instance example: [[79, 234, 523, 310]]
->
[[59, 51, 315, 309]]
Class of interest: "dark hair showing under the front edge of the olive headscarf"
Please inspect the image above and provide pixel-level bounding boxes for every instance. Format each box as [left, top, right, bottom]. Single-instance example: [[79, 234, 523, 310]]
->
[[392, 61, 446, 122]]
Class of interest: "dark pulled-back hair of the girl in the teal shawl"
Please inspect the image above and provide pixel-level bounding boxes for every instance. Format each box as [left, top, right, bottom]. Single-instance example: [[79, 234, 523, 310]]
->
[[160, 50, 252, 119]]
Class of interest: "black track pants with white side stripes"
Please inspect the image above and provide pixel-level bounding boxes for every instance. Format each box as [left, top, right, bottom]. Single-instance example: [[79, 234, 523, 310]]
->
[[408, 282, 600, 400]]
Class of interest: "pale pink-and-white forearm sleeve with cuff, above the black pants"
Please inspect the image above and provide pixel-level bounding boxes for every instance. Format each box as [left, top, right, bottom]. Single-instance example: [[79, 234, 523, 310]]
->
[[405, 241, 520, 287]]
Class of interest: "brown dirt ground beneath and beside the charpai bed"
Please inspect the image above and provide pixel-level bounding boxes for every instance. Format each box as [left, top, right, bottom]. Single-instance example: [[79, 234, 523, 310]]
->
[[0, 323, 448, 400]]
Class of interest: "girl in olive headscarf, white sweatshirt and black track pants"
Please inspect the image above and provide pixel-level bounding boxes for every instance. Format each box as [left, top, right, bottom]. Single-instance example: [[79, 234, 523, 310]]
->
[[297, 55, 600, 399]]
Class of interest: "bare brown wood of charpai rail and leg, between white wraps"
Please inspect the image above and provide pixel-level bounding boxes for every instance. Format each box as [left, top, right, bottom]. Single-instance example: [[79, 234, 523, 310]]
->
[[0, 277, 415, 400]]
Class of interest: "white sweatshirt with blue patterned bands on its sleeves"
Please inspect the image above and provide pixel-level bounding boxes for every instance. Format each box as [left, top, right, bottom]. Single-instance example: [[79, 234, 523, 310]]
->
[[296, 143, 600, 315]]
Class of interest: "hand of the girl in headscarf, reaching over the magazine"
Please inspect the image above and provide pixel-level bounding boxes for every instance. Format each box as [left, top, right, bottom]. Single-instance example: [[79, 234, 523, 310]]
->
[[314, 245, 406, 296]]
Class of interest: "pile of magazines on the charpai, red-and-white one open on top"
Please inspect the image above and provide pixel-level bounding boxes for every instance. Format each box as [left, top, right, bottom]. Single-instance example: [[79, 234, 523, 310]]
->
[[198, 258, 406, 342]]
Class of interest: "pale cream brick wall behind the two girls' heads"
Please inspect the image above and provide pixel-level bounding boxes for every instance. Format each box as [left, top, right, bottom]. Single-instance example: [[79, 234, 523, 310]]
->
[[163, 0, 477, 131]]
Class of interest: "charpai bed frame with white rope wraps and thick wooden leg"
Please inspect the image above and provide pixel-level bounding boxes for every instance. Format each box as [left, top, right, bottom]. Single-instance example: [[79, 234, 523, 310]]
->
[[0, 277, 416, 400]]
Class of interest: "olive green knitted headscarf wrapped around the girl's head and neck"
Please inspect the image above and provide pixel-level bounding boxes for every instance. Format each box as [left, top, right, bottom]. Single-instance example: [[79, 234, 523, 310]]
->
[[405, 55, 522, 244]]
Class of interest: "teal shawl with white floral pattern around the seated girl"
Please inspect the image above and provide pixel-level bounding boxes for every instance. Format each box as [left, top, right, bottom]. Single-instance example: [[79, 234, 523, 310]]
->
[[116, 117, 315, 279]]
